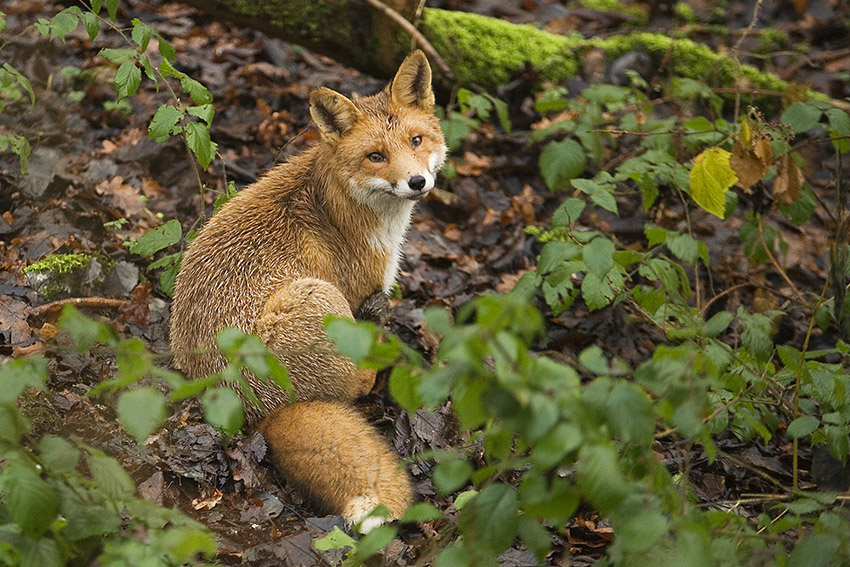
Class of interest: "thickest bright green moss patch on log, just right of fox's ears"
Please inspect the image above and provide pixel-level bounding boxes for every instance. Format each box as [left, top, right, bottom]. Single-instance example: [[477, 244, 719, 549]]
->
[[422, 8, 580, 87]]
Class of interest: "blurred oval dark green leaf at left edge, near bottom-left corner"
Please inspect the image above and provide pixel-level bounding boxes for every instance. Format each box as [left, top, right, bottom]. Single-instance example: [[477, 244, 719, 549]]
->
[[3, 464, 59, 537]]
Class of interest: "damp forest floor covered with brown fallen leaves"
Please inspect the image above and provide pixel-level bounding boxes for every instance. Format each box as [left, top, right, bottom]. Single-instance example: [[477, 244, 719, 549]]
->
[[0, 0, 850, 566]]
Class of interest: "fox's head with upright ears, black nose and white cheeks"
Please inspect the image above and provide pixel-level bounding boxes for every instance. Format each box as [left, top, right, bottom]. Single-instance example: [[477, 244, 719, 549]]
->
[[310, 50, 446, 212]]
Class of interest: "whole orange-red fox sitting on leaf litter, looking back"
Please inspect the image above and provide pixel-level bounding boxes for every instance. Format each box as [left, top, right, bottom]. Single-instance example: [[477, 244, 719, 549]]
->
[[170, 51, 446, 527]]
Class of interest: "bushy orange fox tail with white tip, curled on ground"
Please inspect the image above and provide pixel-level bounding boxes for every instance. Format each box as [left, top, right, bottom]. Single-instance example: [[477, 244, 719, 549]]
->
[[259, 401, 413, 529]]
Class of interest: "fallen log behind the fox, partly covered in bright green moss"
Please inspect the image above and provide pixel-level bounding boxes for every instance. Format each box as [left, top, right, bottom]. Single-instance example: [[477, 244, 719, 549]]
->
[[189, 0, 800, 96]]
